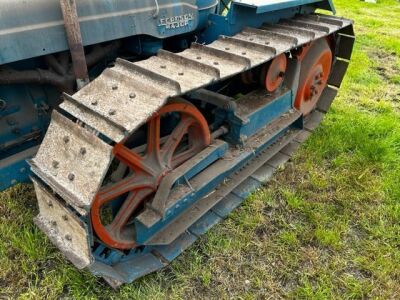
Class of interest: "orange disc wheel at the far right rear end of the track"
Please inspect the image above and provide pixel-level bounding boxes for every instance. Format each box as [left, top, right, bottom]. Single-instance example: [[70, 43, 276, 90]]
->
[[294, 39, 332, 115]]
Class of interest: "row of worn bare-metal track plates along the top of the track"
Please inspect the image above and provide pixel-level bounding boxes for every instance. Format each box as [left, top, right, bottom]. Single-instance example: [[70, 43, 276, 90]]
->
[[57, 15, 351, 142]]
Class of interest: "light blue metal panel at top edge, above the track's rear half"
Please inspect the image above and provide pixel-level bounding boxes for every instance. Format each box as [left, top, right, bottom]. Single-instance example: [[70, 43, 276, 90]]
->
[[233, 0, 334, 14]]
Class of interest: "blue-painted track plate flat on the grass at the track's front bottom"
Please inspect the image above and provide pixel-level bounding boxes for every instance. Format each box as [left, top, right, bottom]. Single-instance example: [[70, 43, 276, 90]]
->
[[113, 253, 165, 282]]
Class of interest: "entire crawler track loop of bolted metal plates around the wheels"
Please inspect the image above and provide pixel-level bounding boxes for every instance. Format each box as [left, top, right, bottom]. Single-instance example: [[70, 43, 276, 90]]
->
[[31, 15, 354, 286]]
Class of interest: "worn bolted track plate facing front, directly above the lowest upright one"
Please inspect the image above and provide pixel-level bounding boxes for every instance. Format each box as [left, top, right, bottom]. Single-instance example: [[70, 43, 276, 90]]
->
[[31, 111, 112, 214]]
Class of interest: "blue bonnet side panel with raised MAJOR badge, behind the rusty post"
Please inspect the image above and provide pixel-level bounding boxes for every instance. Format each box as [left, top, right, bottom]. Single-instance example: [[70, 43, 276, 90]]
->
[[0, 0, 209, 65]]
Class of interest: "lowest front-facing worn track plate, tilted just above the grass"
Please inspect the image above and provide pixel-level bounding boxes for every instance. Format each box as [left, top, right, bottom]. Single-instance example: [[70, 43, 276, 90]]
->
[[33, 180, 91, 269]]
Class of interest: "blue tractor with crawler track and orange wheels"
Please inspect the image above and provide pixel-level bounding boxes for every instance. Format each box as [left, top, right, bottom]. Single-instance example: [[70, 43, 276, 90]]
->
[[0, 0, 354, 286]]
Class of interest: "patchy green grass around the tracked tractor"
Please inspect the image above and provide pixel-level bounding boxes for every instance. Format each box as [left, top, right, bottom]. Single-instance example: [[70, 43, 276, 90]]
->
[[0, 0, 400, 299]]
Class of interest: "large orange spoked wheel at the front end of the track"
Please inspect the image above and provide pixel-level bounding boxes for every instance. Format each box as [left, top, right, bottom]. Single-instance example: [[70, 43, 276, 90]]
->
[[91, 101, 211, 249]]
